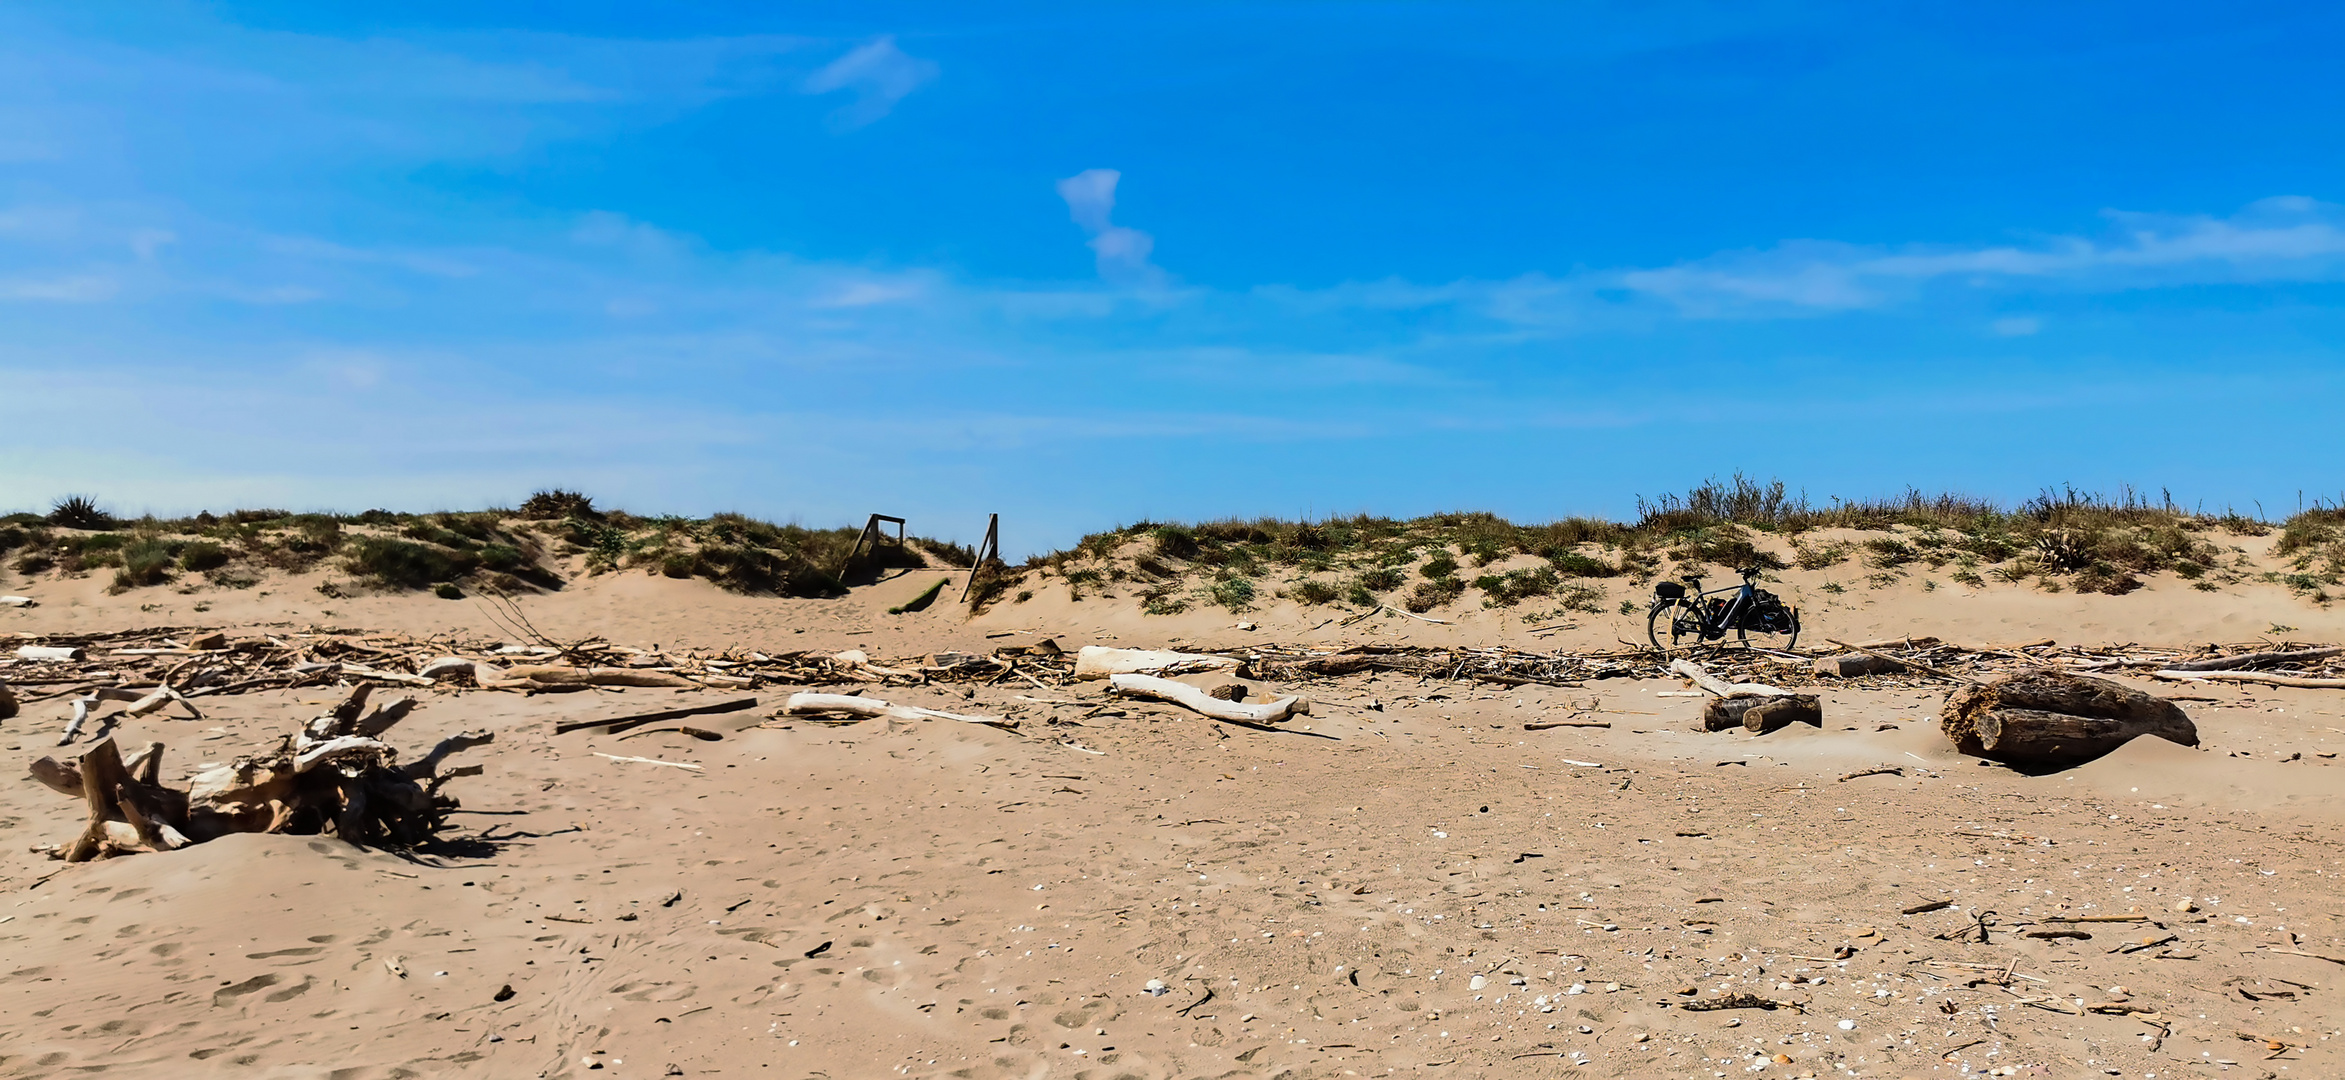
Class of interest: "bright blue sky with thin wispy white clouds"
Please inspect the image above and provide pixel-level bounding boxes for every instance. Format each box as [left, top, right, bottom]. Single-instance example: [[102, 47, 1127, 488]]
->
[[0, 0, 2345, 553]]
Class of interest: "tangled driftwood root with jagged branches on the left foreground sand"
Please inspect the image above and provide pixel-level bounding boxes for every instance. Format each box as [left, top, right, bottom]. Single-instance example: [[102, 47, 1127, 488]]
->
[[33, 684, 492, 862]]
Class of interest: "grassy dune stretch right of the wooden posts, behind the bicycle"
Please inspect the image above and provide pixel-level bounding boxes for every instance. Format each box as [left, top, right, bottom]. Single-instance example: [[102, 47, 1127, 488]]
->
[[984, 476, 2307, 614]]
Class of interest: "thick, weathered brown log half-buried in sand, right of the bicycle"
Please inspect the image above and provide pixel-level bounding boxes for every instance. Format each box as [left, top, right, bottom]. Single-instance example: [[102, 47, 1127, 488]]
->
[[1939, 670, 2197, 768]]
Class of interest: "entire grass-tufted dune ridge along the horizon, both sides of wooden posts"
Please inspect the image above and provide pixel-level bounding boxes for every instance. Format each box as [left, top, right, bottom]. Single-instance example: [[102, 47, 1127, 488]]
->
[[0, 476, 2345, 614]]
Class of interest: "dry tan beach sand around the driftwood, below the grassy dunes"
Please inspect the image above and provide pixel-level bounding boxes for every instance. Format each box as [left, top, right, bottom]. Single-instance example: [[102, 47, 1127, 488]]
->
[[0, 559, 2345, 1080]]
